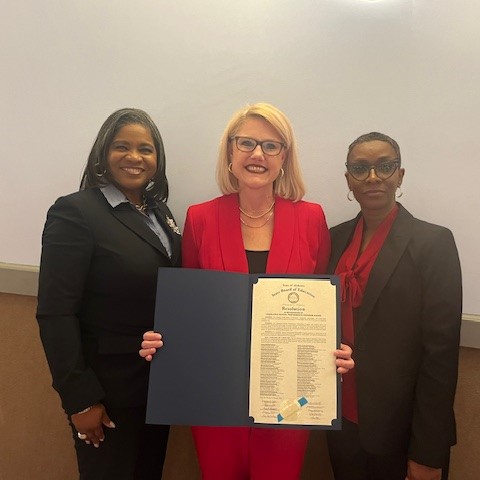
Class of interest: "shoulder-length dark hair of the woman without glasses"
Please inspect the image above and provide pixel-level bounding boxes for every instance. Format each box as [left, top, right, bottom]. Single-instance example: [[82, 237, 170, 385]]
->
[[80, 108, 168, 201]]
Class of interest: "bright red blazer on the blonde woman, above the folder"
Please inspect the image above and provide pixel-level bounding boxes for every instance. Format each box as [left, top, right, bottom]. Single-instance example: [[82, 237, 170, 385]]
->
[[182, 194, 330, 274]]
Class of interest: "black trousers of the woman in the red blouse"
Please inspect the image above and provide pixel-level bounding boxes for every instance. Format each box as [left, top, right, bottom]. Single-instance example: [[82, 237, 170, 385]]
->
[[327, 418, 450, 480]]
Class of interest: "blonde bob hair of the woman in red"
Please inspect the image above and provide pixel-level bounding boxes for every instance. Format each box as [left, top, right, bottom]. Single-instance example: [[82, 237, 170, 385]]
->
[[217, 103, 305, 202]]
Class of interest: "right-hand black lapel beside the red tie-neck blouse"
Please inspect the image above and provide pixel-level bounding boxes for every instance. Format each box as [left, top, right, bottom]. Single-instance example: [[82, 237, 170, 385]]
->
[[355, 204, 413, 335]]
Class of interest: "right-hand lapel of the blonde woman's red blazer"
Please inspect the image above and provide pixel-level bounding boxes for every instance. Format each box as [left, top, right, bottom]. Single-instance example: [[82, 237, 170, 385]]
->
[[267, 197, 297, 273]]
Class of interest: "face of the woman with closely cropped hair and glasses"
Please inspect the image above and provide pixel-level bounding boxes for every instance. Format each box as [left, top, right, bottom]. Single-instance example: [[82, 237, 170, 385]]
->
[[345, 140, 405, 215]]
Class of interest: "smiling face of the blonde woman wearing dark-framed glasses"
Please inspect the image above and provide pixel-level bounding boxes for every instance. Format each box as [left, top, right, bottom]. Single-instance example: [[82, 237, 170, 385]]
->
[[229, 117, 285, 195]]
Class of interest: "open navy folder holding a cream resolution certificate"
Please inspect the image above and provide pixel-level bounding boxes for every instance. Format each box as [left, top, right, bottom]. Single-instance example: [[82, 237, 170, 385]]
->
[[147, 268, 341, 429]]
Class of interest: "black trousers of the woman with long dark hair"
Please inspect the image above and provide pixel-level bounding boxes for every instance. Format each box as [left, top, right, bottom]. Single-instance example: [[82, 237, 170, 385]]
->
[[71, 407, 170, 480]]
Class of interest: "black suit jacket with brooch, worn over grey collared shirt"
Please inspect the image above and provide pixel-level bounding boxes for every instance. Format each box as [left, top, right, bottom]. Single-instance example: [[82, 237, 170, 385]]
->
[[37, 188, 180, 414]]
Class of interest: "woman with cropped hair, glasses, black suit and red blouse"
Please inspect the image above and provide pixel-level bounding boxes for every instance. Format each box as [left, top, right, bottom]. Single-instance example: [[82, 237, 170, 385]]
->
[[328, 132, 462, 480]]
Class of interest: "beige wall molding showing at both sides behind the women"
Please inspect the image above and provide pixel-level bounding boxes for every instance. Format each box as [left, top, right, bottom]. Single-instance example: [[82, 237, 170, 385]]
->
[[0, 262, 480, 348]]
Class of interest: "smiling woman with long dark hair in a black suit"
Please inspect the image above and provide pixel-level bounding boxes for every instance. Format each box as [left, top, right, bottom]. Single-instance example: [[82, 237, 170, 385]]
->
[[37, 109, 180, 480]]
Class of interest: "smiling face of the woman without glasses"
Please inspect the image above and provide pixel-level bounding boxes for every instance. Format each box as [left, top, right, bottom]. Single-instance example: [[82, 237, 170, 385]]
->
[[107, 124, 157, 204]]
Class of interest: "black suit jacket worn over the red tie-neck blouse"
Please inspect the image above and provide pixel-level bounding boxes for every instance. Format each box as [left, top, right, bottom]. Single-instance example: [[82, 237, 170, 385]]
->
[[329, 205, 462, 467]]
